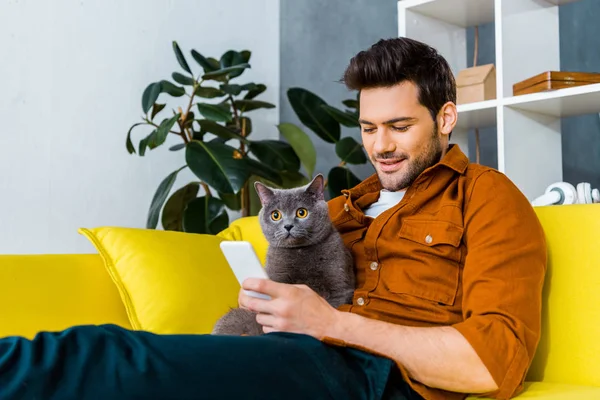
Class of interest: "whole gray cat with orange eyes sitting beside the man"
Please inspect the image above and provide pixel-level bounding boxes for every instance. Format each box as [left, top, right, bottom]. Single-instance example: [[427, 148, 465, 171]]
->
[[212, 174, 355, 336]]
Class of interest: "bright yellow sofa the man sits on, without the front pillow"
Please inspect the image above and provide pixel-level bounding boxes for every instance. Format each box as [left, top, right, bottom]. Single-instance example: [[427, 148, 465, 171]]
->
[[0, 204, 600, 400]]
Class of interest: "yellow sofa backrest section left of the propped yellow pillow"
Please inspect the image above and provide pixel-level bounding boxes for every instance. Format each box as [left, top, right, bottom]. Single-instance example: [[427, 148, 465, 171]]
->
[[0, 254, 131, 339]]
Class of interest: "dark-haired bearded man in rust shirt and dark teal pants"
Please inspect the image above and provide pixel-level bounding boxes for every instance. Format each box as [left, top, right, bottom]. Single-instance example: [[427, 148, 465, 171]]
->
[[0, 38, 546, 400]]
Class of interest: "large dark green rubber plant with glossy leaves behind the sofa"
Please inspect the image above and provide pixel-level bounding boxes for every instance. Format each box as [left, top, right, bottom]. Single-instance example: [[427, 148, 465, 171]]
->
[[126, 41, 367, 234]]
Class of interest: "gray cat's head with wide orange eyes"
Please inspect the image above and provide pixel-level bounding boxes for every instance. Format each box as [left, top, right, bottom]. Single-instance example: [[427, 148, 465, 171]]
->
[[254, 174, 331, 247]]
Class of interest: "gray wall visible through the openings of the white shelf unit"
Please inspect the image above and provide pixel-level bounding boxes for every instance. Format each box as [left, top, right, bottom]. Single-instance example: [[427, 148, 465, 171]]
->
[[467, 0, 600, 187]]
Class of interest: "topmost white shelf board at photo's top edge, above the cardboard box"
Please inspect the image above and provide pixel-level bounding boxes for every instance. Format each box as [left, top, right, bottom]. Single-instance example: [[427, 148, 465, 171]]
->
[[398, 0, 494, 28]]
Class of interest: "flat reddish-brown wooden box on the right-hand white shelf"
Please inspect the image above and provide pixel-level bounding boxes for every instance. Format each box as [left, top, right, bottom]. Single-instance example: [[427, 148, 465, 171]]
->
[[513, 71, 600, 96]]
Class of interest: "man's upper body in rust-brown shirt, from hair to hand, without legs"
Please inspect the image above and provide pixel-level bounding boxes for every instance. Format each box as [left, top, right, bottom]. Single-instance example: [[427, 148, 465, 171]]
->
[[240, 38, 546, 400]]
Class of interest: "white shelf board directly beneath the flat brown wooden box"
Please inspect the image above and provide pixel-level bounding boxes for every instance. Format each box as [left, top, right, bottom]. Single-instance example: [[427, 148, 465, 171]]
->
[[504, 83, 600, 118]]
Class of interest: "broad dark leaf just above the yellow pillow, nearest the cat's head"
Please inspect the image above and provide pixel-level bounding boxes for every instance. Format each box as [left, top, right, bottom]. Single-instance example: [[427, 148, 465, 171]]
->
[[183, 196, 229, 235]]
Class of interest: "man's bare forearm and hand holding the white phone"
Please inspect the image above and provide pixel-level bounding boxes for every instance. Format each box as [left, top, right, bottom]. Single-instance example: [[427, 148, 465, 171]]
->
[[239, 279, 497, 393]]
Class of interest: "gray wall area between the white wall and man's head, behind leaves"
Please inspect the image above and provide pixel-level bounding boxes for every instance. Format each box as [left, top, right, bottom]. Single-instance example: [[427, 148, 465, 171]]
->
[[280, 0, 398, 184]]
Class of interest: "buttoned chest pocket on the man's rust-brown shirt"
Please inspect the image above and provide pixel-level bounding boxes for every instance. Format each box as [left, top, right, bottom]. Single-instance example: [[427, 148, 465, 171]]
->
[[382, 219, 463, 305]]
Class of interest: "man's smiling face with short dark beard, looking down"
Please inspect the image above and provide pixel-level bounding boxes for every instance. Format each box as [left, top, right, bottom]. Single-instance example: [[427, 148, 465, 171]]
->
[[360, 82, 448, 191]]
